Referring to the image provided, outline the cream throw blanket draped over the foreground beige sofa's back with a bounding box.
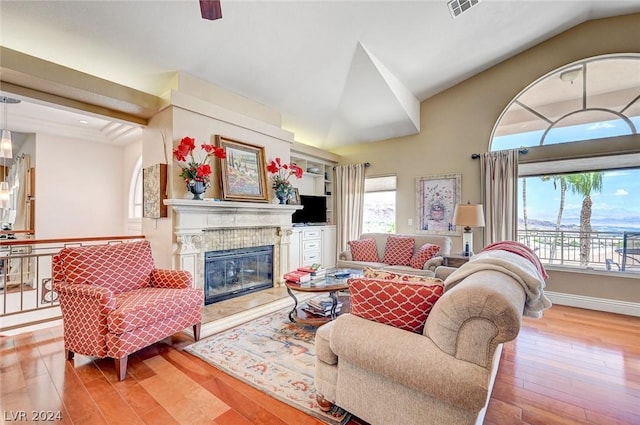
[444,251,551,318]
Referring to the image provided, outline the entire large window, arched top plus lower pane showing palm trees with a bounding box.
[490,54,640,272]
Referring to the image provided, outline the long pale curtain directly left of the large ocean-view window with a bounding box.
[480,149,518,245]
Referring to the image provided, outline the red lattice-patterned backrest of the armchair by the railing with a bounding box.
[59,238,154,295]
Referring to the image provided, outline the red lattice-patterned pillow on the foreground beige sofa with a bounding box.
[348,278,444,333]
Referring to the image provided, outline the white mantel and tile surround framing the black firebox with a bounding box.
[165,199,301,302]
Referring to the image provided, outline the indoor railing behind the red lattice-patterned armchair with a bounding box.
[0,235,144,333]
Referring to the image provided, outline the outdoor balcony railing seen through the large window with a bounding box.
[518,230,640,272]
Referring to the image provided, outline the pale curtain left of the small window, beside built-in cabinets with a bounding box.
[335,164,366,252]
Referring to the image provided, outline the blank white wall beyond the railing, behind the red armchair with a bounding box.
[34,133,130,239]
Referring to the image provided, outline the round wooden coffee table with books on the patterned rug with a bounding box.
[285,270,362,326]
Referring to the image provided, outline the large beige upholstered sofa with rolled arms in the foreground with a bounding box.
[315,265,532,425]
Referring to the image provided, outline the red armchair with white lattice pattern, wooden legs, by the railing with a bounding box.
[53,241,204,381]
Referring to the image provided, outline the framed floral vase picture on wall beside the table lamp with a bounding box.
[416,174,461,235]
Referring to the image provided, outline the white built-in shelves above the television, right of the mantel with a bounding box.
[291,153,334,224]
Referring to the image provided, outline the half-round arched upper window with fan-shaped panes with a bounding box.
[490,54,640,151]
